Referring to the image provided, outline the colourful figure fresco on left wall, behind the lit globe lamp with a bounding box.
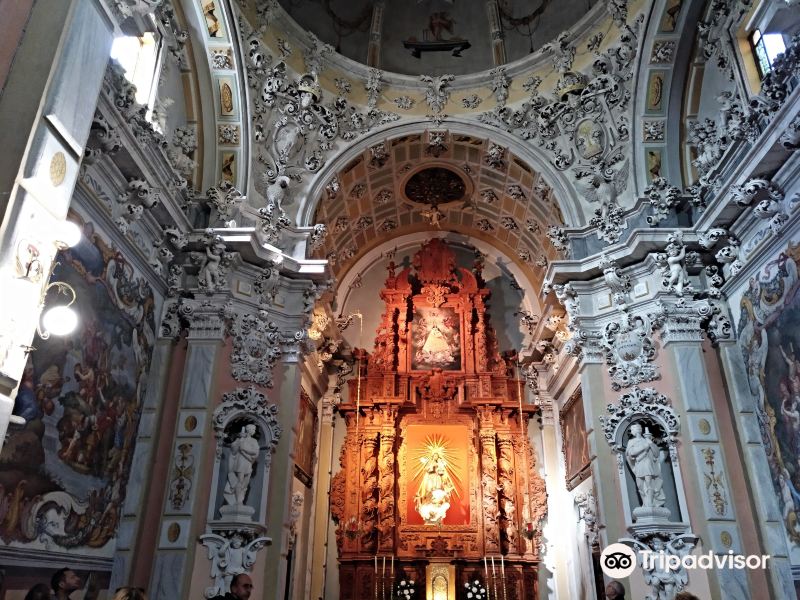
[0,218,156,552]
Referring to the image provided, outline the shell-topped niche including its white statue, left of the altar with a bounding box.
[208,387,281,523]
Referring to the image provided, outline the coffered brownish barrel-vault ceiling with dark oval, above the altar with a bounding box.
[314,131,563,280]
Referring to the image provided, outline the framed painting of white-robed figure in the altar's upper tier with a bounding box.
[411,307,461,371]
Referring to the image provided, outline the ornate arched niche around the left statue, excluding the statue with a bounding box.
[208,386,282,523]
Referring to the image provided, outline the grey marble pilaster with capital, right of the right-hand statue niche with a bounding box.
[661,301,766,600]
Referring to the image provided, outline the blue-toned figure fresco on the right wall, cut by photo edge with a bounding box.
[738,243,800,546]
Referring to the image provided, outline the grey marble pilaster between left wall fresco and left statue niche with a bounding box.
[149,301,225,600]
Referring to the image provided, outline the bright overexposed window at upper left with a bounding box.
[111,31,161,120]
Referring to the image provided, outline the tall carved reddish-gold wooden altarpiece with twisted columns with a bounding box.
[331,239,546,600]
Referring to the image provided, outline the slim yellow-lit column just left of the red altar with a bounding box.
[309,394,341,598]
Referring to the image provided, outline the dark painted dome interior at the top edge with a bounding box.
[280,0,598,75]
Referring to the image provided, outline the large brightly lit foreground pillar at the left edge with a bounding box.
[0,0,114,447]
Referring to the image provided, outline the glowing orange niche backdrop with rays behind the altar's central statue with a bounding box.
[405,425,472,525]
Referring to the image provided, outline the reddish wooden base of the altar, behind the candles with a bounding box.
[339,557,539,600]
